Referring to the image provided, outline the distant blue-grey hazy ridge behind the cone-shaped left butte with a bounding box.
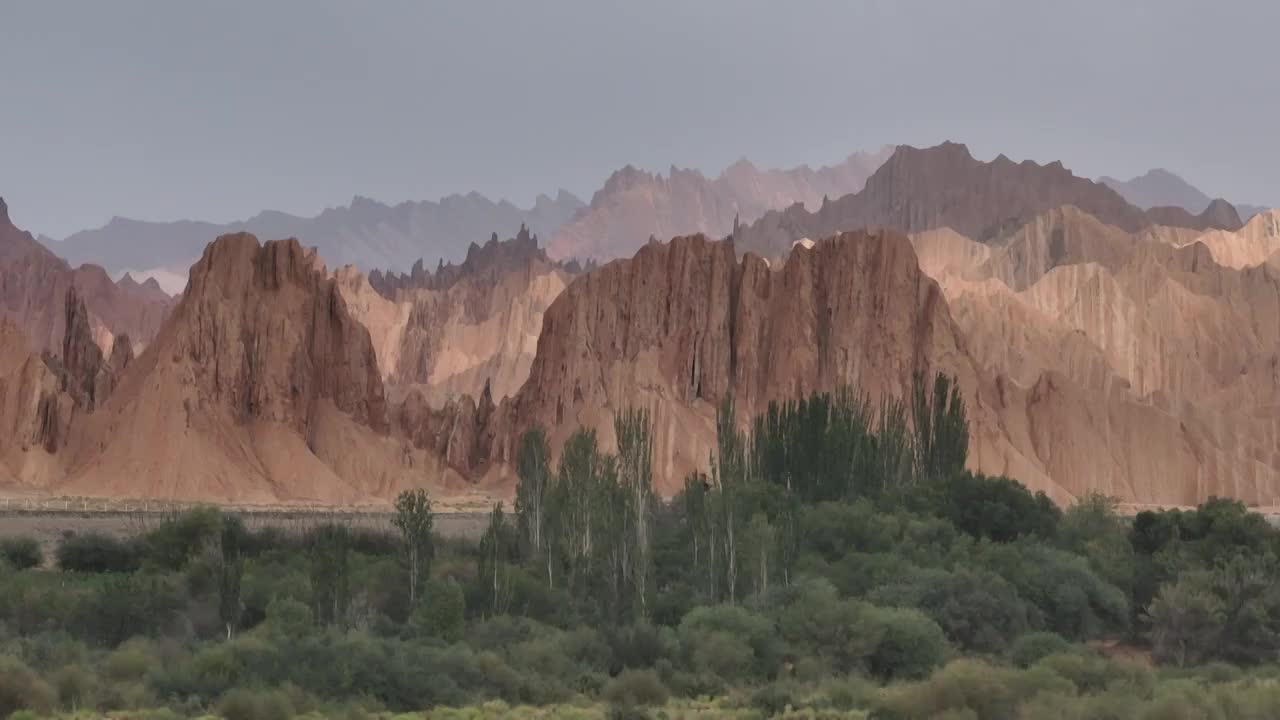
[47,190,584,286]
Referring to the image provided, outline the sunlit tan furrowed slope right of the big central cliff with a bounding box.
[914,209,1280,505]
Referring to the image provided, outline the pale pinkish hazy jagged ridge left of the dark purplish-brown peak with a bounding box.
[548,146,893,260]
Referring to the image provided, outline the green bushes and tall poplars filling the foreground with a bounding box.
[0,377,1280,720]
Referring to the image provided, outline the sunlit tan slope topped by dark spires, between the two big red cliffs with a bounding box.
[337,227,577,407]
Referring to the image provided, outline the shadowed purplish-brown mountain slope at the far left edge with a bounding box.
[0,199,173,352]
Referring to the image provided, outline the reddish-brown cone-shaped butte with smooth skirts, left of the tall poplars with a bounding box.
[55,234,450,503]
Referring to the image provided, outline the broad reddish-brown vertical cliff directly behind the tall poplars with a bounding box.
[476,233,975,493]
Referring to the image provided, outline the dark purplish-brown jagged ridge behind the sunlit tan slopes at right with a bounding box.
[735,142,1239,256]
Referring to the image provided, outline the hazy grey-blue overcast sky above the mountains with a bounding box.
[0,0,1280,237]
